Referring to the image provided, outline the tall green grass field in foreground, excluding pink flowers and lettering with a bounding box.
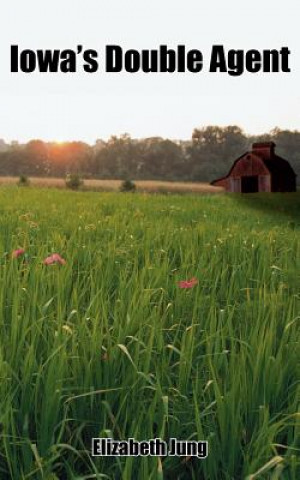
[0,186,300,480]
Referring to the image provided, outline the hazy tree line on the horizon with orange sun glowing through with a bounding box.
[0,126,300,183]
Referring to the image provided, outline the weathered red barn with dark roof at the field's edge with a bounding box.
[211,142,296,193]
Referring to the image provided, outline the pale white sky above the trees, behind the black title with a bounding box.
[0,0,300,143]
